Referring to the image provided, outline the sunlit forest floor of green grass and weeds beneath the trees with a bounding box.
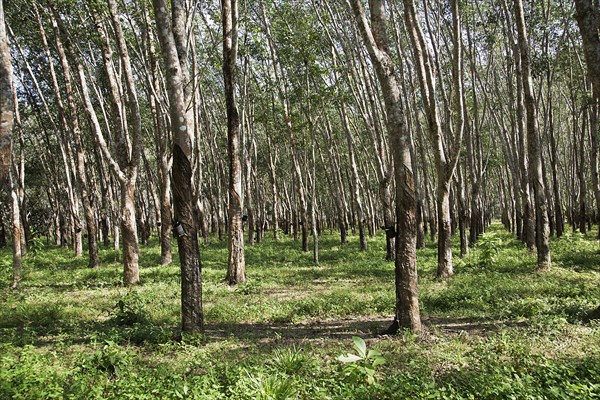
[0,226,600,399]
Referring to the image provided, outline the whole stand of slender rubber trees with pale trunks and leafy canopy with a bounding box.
[0,0,600,331]
